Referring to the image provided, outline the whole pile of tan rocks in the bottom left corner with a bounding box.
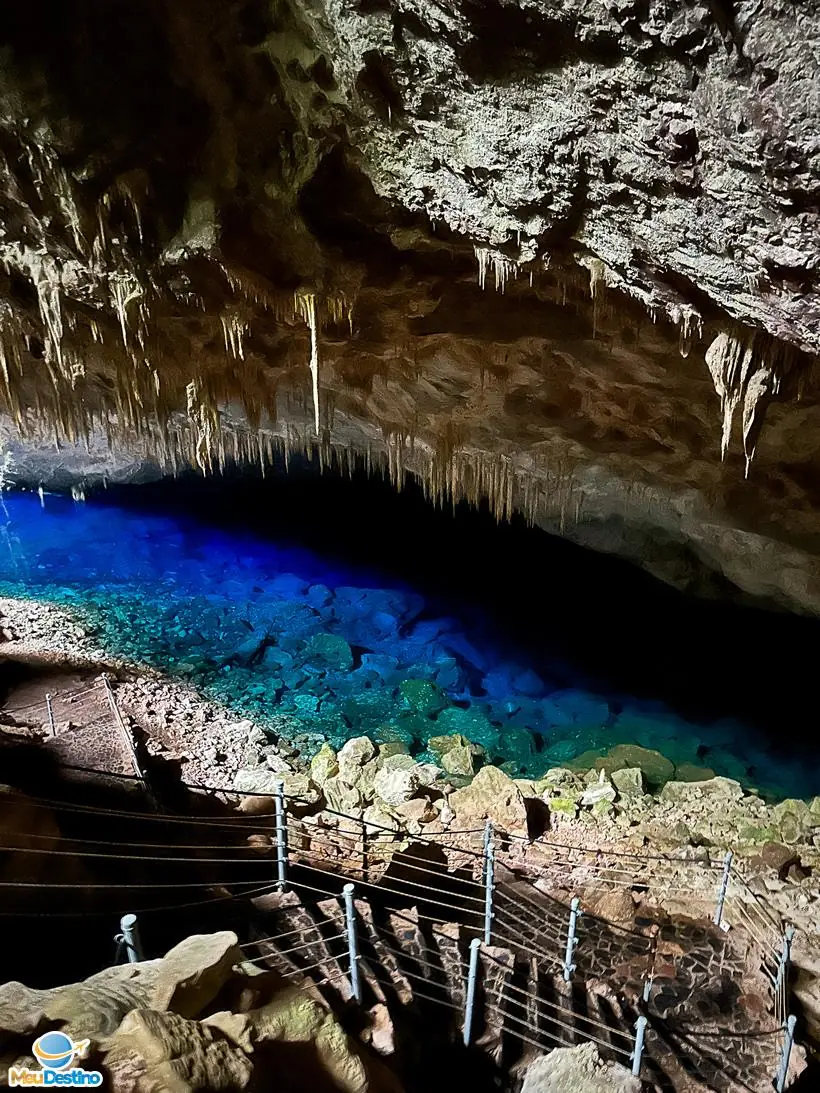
[0,932,399,1093]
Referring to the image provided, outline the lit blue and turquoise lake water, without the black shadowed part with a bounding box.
[0,483,820,796]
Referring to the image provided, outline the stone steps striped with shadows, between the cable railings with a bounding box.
[246,878,773,1093]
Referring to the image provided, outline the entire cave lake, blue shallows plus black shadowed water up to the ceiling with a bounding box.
[0,468,820,797]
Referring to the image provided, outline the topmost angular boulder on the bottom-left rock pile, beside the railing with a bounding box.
[150,930,243,1018]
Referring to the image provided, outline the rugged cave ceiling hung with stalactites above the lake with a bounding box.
[0,0,820,612]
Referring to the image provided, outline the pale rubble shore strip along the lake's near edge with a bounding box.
[0,600,820,1053]
